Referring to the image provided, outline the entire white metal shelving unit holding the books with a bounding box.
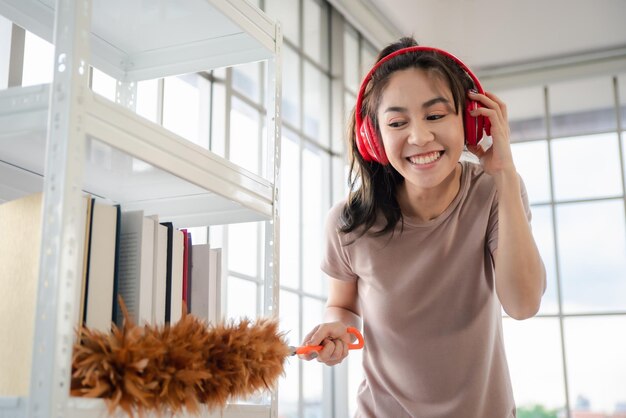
[0,0,282,418]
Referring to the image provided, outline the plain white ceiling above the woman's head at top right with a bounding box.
[361,0,626,72]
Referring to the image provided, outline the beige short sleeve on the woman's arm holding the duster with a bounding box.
[320,202,358,281]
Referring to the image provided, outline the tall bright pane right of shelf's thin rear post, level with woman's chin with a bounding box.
[280,129,300,289]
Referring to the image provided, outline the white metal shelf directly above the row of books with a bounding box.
[0,85,273,227]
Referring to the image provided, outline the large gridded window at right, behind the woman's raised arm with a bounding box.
[496,75,626,417]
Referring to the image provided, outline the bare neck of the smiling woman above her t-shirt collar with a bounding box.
[397,164,463,221]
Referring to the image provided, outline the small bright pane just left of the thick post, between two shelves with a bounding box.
[22,31,54,86]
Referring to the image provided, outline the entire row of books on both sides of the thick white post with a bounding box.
[0,193,222,396]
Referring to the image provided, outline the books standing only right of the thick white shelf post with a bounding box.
[77,193,221,331]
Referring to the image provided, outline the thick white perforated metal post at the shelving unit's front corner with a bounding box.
[27,0,91,418]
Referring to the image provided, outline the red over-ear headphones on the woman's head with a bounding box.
[355,46,491,165]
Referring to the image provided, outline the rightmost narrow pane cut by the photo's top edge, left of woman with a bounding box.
[303,0,329,68]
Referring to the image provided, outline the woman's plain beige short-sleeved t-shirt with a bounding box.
[322,162,530,418]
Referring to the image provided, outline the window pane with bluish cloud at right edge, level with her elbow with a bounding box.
[556,199,626,313]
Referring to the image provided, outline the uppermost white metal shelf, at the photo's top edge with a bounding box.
[0,0,276,81]
